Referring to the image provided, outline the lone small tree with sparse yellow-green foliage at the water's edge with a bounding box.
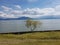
[25,19,41,31]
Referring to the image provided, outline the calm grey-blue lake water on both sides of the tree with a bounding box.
[0,19,60,33]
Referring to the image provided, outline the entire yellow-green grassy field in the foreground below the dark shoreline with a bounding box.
[0,31,60,45]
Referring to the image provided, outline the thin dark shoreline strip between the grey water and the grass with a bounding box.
[0,30,60,34]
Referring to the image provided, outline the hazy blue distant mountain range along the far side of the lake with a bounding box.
[0,15,60,20]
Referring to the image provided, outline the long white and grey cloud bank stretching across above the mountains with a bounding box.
[0,5,60,18]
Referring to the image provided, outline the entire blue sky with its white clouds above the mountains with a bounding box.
[0,0,60,18]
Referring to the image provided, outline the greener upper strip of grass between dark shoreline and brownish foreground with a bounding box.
[0,32,60,39]
